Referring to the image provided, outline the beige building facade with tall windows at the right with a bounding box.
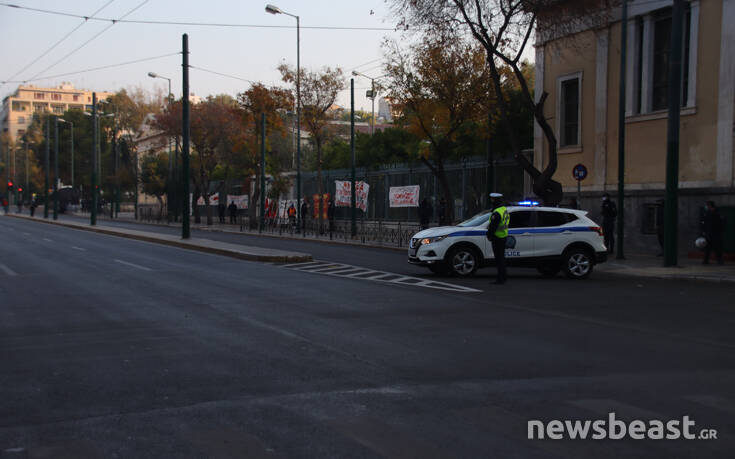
[534,0,735,251]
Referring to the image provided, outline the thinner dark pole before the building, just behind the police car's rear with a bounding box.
[617,0,628,260]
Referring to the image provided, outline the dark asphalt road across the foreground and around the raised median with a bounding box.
[0,217,735,459]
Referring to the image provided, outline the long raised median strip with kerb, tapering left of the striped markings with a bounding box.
[8,215,313,263]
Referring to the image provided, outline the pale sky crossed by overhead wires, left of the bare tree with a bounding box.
[0,0,399,111]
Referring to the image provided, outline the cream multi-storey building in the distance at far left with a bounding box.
[0,83,113,141]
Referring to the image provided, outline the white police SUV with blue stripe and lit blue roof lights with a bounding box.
[408,206,607,279]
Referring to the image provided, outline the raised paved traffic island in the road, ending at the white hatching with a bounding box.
[8,213,312,263]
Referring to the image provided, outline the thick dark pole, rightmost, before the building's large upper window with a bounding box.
[664,0,684,266]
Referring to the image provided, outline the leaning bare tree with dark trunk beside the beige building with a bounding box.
[392,0,614,206]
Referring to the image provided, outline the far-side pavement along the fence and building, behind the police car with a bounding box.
[59,214,735,283]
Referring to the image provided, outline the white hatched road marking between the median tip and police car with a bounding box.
[282,260,482,293]
